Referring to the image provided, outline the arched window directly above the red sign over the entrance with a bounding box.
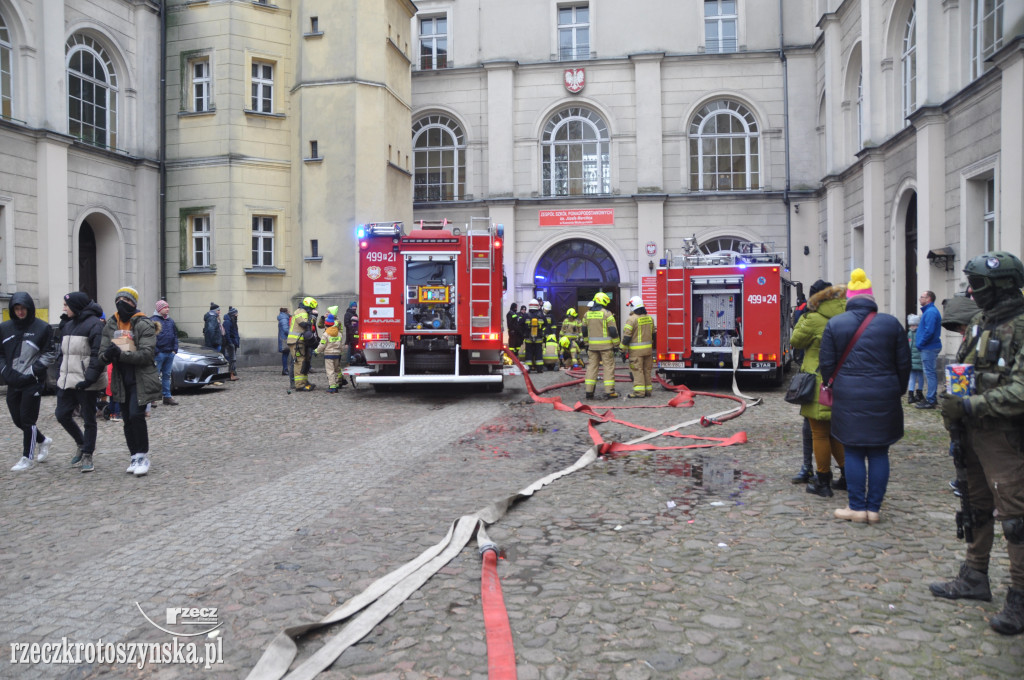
[541,107,611,196]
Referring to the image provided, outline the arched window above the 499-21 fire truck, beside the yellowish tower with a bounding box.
[413,115,466,201]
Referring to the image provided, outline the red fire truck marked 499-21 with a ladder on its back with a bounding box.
[354,217,505,391]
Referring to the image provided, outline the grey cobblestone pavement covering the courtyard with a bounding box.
[0,368,1024,680]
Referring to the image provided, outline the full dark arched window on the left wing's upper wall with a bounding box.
[66,35,118,148]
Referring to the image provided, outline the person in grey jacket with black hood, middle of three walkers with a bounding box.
[53,291,106,472]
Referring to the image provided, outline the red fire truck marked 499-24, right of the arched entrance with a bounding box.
[656,238,793,384]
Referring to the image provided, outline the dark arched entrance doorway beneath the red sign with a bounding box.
[534,239,620,321]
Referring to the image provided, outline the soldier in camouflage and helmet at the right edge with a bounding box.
[931,252,1024,635]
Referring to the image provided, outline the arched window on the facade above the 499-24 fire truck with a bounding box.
[690,99,761,192]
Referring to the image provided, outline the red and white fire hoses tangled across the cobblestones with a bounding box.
[247,348,761,680]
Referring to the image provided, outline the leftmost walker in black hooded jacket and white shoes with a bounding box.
[0,291,57,472]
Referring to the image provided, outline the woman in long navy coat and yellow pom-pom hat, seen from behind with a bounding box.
[818,269,910,524]
